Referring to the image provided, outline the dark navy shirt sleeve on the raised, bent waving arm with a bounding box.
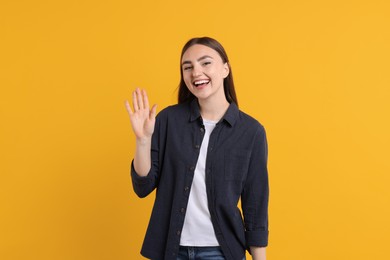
[130,112,161,198]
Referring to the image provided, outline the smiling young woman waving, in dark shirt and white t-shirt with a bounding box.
[126,37,268,260]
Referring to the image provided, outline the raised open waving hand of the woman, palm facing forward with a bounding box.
[125,88,157,142]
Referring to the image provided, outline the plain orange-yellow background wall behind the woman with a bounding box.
[0,0,390,260]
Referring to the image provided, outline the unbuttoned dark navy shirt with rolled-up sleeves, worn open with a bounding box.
[131,99,269,260]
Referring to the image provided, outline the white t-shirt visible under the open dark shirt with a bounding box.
[180,120,219,246]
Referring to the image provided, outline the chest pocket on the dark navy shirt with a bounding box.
[225,149,250,181]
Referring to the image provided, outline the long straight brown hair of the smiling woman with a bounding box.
[178,37,238,106]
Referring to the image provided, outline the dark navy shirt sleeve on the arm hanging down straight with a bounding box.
[241,126,269,249]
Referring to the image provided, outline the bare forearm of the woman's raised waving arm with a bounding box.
[134,138,152,176]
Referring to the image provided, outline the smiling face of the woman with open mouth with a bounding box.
[181,44,229,100]
